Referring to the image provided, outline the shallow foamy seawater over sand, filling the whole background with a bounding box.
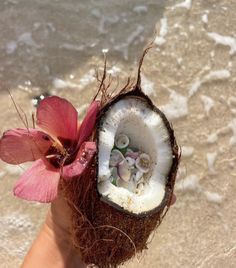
[0,0,236,268]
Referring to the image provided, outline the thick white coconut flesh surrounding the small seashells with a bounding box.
[98,96,173,214]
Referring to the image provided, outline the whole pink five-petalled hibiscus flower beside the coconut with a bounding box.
[0,96,100,202]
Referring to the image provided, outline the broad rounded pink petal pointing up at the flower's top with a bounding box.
[37,96,78,141]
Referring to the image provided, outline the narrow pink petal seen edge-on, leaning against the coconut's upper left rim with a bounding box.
[78,101,100,147]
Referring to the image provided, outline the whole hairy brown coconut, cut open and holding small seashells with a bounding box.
[64,48,179,268]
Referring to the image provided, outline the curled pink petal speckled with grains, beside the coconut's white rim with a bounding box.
[62,142,96,180]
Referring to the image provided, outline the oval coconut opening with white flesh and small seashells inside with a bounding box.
[97,94,175,215]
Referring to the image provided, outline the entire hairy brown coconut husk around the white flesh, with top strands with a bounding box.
[63,48,179,268]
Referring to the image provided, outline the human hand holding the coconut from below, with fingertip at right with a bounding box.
[22,191,176,268]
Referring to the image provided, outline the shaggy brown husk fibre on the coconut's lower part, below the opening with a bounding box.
[65,152,178,268]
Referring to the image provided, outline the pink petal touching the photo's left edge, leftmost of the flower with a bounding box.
[0,128,52,165]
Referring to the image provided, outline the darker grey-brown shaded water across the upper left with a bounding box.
[0,0,165,88]
